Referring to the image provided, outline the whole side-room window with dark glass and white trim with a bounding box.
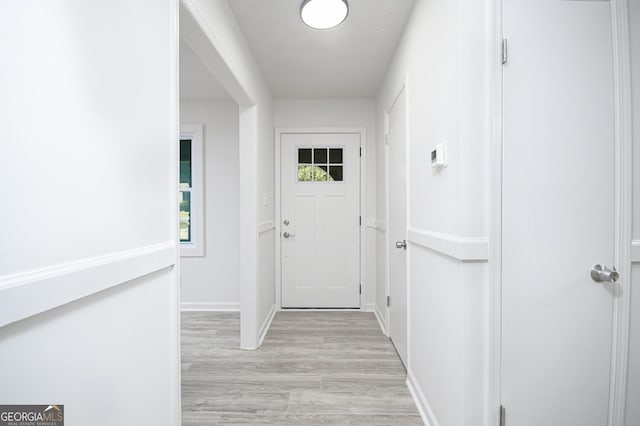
[178,125,204,257]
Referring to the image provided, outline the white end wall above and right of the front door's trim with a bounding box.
[274,99,376,309]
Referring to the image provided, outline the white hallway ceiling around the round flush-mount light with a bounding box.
[228,0,415,98]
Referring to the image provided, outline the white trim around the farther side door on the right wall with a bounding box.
[383,73,411,371]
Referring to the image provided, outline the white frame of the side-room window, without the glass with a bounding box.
[178,124,205,257]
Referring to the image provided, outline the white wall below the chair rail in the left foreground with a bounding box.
[0,270,175,426]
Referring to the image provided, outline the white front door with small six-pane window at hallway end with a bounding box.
[280,133,360,308]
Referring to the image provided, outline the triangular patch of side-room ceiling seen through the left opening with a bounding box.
[180,40,231,100]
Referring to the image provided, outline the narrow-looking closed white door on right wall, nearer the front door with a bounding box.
[387,90,407,365]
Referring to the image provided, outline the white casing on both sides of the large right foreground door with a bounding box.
[485,0,633,426]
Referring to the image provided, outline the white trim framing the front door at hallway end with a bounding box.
[275,127,370,311]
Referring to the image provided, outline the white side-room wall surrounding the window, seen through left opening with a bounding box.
[180,99,240,310]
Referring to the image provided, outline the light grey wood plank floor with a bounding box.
[182,312,423,426]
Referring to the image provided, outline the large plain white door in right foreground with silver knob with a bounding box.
[502,0,615,426]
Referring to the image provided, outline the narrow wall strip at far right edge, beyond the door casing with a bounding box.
[626,0,640,426]
